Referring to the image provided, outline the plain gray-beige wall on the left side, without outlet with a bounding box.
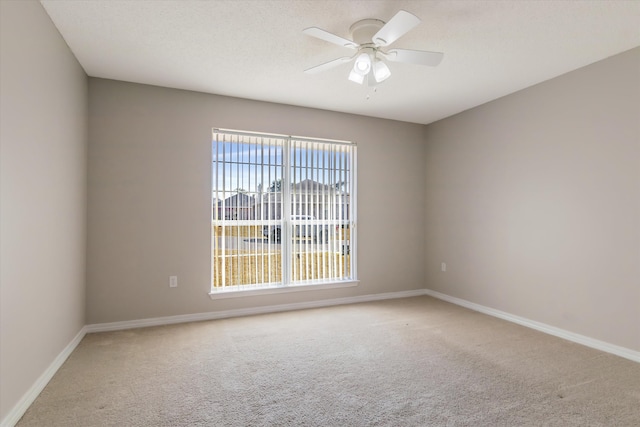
[0,1,87,419]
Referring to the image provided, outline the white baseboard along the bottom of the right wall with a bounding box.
[423,289,640,363]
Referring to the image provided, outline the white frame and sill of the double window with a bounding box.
[209,128,359,299]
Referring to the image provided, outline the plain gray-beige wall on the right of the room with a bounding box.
[424,48,640,351]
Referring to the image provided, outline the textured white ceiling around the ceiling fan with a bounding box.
[41,0,640,124]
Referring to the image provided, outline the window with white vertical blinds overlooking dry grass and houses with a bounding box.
[211,129,356,296]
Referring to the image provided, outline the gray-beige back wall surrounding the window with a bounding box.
[87,78,425,323]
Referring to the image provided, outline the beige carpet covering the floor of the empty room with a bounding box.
[18,297,640,427]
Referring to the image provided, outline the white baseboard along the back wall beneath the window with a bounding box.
[86,289,424,333]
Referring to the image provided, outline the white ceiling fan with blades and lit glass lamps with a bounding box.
[302,10,444,86]
